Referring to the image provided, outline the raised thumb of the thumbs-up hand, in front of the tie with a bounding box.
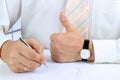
[60,12,76,32]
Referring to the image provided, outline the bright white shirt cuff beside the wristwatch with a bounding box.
[93,39,120,64]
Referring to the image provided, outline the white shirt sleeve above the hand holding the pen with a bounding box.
[0,0,21,48]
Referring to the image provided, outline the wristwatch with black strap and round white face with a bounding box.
[80,39,90,62]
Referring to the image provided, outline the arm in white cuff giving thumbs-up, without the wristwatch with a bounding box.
[51,14,120,63]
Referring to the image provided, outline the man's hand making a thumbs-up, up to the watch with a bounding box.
[50,13,84,62]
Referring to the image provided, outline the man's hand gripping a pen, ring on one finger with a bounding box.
[1,39,45,72]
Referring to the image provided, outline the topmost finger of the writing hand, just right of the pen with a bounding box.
[26,39,44,54]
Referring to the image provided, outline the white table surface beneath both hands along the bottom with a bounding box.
[0,51,120,80]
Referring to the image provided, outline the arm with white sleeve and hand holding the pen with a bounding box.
[0,0,45,72]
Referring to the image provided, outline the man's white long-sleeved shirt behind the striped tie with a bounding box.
[0,0,120,62]
